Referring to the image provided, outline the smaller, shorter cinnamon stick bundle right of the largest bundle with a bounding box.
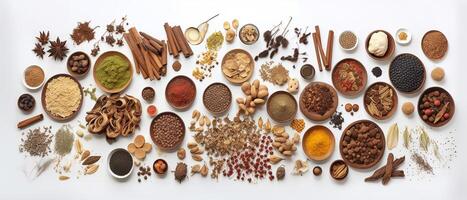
[164,23,193,58]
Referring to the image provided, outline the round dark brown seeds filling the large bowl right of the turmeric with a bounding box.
[342,122,384,165]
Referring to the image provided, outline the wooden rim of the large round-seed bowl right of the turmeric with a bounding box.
[339,119,386,169]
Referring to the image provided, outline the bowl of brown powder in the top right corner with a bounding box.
[422,31,448,60]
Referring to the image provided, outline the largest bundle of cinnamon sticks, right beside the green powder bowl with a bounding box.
[123,27,167,80]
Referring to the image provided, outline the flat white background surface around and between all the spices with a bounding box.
[0,0,467,199]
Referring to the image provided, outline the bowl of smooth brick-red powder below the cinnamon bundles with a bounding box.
[165,75,196,109]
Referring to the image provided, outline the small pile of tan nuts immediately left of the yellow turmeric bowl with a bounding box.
[272,125,300,157]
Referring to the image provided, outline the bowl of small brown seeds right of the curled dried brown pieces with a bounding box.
[151,113,185,149]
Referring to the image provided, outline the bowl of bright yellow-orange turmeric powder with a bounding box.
[303,126,334,160]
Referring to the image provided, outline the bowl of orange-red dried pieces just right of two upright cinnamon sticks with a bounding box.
[332,58,368,97]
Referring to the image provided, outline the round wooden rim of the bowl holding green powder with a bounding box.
[93,51,133,94]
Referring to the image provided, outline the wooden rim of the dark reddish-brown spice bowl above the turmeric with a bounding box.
[299,82,339,121]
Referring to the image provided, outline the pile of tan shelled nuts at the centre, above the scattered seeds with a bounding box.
[237,80,269,115]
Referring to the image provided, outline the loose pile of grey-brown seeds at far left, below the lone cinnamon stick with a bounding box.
[19,127,53,157]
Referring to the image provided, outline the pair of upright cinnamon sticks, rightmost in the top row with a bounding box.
[313,26,334,71]
